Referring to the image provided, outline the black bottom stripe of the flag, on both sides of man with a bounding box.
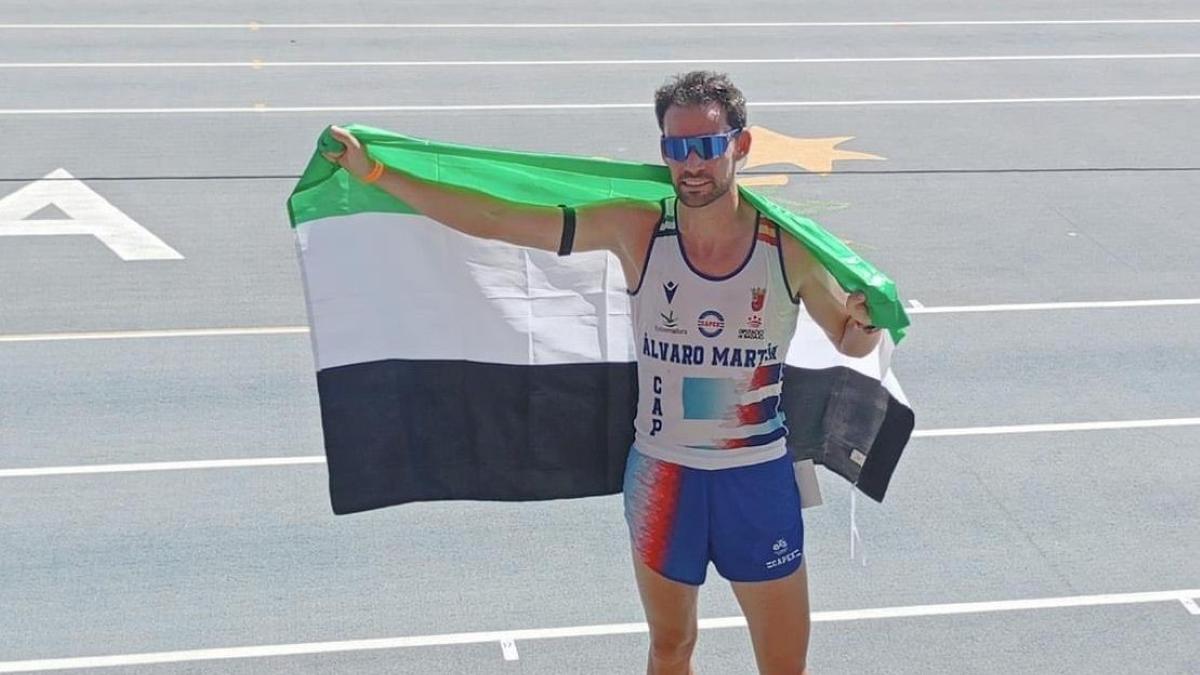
[317,359,913,515]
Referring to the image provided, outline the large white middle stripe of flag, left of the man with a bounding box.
[296,214,634,370]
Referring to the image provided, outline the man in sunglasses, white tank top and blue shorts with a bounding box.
[326,71,880,675]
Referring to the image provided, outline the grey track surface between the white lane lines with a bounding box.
[0,0,1200,675]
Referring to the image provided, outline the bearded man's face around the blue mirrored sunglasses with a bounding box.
[662,103,750,207]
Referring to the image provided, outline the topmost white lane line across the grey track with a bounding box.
[0,18,1200,30]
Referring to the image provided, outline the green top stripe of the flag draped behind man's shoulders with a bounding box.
[288,125,910,344]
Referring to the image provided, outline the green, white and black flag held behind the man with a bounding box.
[288,126,913,514]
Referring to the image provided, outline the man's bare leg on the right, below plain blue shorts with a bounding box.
[732,565,810,675]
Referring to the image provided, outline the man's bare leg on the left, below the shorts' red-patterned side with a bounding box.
[634,554,700,675]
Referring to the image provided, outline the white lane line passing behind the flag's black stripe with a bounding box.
[0,417,1200,478]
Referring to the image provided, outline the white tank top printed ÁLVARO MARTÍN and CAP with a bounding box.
[630,198,799,468]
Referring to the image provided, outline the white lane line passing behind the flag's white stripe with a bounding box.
[0,298,1200,344]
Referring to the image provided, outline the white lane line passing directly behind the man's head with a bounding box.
[0,94,1200,115]
